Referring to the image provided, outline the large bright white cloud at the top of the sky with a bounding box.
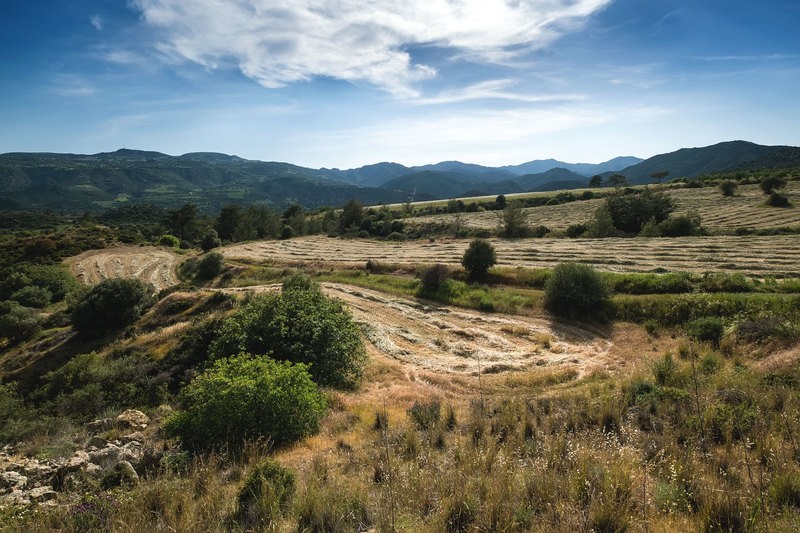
[132,0,612,96]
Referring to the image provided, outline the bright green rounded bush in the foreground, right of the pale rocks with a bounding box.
[165,354,326,450]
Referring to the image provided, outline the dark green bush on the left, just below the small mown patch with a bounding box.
[72,279,154,334]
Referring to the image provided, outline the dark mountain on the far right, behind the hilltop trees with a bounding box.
[620,141,796,184]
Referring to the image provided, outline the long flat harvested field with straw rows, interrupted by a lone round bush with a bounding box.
[220,235,800,277]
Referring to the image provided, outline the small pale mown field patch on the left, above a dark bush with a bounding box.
[66,246,179,290]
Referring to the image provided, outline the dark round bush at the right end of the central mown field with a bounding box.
[544,263,611,318]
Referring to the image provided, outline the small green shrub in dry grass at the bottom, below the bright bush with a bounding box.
[236,459,295,528]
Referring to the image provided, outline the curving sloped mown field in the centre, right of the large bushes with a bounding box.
[323,283,611,375]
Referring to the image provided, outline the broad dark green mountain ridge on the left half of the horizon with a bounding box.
[0,150,406,211]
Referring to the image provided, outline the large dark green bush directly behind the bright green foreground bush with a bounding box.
[209,286,366,387]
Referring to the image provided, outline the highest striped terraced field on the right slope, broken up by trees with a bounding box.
[408,181,800,230]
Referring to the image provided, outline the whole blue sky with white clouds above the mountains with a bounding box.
[0,0,800,168]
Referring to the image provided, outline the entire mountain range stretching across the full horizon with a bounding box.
[0,141,800,212]
